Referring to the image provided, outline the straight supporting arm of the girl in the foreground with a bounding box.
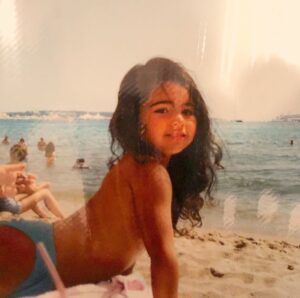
[133,163,178,298]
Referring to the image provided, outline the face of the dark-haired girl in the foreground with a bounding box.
[140,82,197,162]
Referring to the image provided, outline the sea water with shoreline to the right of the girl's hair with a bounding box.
[207,121,300,239]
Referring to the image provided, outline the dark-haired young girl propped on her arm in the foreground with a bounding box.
[0,58,219,298]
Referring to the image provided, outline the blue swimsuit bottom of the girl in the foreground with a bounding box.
[0,219,56,298]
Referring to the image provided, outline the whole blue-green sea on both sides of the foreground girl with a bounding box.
[0,116,300,239]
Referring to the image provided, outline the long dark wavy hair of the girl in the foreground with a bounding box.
[108,58,222,229]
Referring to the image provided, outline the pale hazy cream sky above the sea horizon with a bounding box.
[0,0,300,121]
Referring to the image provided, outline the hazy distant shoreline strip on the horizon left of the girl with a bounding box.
[0,111,112,122]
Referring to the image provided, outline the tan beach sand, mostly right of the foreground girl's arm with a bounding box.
[0,212,300,298]
